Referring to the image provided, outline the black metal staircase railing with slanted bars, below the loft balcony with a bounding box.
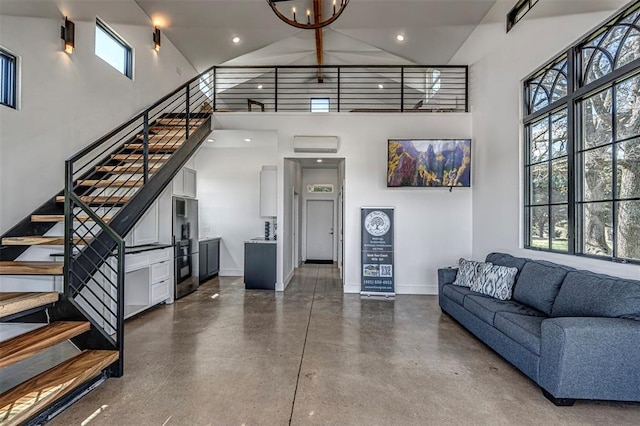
[64,70,213,375]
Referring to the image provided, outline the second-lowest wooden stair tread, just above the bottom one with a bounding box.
[0,321,91,368]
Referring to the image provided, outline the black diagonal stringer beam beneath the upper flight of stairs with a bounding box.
[69,116,211,290]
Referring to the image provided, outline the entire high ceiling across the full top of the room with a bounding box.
[0,0,623,71]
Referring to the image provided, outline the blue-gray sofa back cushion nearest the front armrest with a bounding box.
[551,271,640,321]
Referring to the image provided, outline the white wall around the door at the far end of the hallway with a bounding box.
[301,168,339,261]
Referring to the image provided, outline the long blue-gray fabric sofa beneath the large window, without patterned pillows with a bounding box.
[438,253,640,405]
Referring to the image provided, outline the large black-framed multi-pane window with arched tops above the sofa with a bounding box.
[524,3,640,262]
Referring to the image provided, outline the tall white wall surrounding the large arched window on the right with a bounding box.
[452,0,640,278]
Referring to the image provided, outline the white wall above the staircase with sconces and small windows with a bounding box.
[0,10,196,233]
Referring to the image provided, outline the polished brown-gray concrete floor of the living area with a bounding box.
[50,265,640,426]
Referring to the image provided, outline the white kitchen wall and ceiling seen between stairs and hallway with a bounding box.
[195,130,280,276]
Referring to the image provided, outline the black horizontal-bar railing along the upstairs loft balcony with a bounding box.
[206,65,469,113]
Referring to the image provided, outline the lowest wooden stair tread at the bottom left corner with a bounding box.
[0,350,118,425]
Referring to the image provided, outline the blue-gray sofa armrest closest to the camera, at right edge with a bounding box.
[539,317,640,401]
